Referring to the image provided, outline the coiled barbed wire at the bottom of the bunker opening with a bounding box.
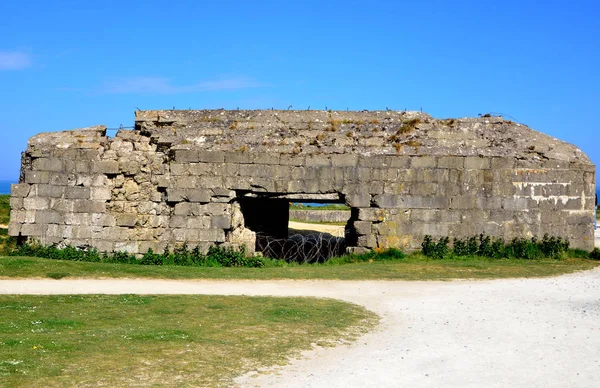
[256,233,346,264]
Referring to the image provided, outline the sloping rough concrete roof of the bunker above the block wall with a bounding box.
[135,109,591,164]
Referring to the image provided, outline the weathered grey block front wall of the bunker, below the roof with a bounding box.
[9,112,595,253]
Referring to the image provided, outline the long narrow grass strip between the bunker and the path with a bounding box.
[0,254,600,280]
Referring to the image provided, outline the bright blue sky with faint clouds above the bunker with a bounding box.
[0,0,600,188]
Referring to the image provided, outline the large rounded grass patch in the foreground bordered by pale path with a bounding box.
[0,295,377,387]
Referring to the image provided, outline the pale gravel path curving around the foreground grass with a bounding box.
[0,268,600,388]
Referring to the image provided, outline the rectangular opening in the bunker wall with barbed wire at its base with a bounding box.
[240,198,358,263]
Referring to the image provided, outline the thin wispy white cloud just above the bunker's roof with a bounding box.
[103,77,266,94]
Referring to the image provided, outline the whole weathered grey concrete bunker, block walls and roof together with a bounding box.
[9,110,595,254]
